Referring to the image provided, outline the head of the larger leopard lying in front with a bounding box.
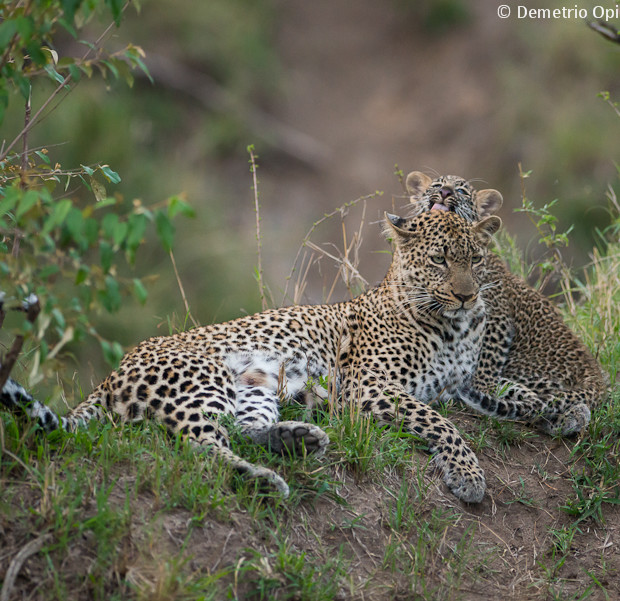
[385,211,502,318]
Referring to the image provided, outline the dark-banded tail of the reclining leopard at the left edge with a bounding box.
[0,378,103,432]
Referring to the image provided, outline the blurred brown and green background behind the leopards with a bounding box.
[1,0,620,379]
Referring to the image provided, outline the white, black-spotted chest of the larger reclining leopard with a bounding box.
[409,310,484,403]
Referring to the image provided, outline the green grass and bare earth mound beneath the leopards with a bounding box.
[0,207,620,601]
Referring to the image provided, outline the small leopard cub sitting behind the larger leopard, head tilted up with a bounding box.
[407,171,606,435]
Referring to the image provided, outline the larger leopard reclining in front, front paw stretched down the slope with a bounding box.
[0,211,501,502]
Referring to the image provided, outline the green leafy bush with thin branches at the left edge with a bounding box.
[0,0,193,385]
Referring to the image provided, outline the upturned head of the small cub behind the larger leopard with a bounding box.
[406,171,503,223]
